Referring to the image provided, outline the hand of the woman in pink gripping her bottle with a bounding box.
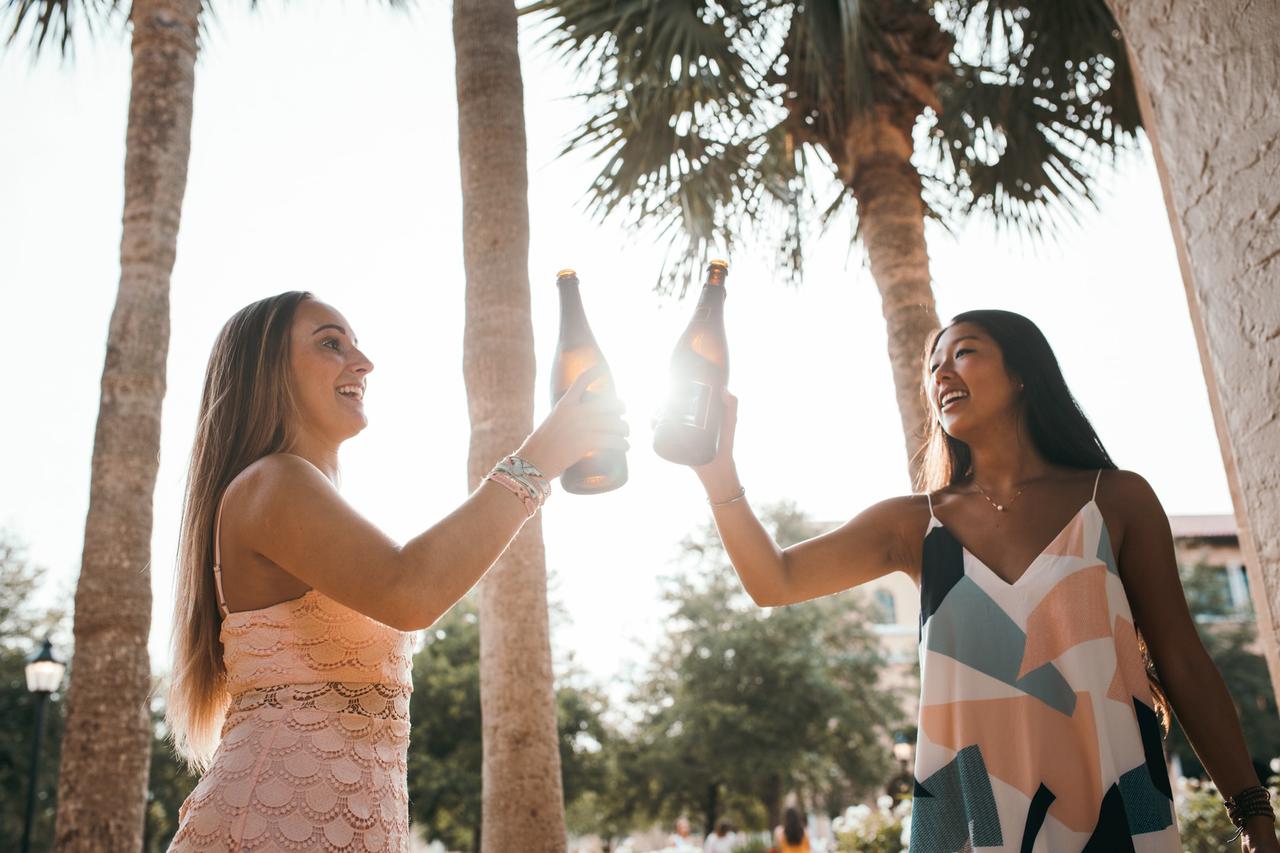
[516,365,630,480]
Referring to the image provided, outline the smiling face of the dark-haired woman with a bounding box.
[928,323,1021,443]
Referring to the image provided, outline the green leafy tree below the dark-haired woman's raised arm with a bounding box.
[618,505,900,827]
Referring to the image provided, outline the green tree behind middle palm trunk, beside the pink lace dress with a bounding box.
[408,598,611,850]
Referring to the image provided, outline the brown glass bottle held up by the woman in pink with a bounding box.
[552,269,627,494]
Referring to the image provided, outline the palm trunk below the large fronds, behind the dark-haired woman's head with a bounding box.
[842,106,938,483]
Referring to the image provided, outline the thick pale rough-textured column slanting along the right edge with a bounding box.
[1108,0,1280,694]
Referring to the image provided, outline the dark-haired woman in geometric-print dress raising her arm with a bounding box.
[680,311,1280,853]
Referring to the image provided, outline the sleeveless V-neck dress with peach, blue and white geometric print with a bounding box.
[910,471,1181,853]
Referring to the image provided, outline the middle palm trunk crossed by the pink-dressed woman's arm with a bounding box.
[453,0,566,853]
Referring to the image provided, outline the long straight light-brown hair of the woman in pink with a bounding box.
[165,291,314,770]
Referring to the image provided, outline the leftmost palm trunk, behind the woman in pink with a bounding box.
[54,0,200,850]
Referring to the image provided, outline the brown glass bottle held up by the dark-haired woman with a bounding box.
[653,260,728,465]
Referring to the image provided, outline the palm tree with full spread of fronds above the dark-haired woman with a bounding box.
[524,0,1139,478]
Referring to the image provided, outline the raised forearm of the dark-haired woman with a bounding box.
[699,470,787,607]
